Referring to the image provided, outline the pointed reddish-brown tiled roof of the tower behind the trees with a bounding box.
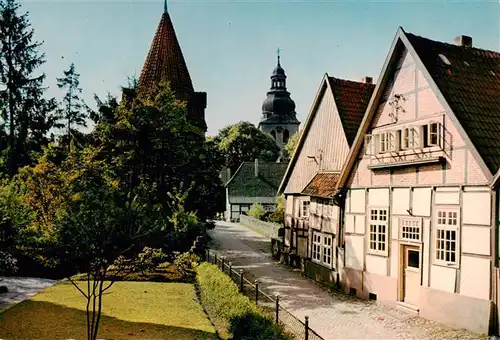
[139,2,194,100]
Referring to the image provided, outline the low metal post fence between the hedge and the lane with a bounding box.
[205,249,324,340]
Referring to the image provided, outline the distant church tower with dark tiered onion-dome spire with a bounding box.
[259,49,300,149]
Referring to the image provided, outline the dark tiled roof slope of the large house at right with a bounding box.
[406,33,500,173]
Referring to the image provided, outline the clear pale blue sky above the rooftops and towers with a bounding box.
[22,0,500,135]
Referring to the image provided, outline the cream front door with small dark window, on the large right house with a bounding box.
[403,245,421,306]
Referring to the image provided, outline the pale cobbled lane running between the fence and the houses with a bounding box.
[210,222,486,340]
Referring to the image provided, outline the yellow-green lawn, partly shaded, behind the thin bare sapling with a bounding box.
[0,281,217,340]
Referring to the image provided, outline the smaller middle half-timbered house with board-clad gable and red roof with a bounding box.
[279,74,375,264]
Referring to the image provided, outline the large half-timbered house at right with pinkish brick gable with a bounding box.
[336,28,500,333]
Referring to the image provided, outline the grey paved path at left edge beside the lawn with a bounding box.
[0,277,57,313]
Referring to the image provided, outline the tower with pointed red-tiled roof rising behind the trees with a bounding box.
[130,0,207,132]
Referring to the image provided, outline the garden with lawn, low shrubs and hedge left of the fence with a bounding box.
[0,248,290,340]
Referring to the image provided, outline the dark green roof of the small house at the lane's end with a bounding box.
[226,162,287,197]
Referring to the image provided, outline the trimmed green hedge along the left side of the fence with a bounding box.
[196,262,291,340]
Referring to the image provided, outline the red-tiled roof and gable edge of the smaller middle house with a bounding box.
[279,73,375,193]
